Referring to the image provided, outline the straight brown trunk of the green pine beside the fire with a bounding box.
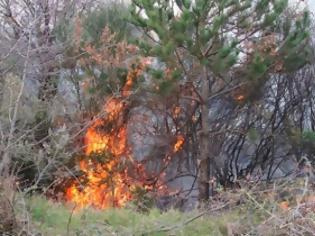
[198,69,210,203]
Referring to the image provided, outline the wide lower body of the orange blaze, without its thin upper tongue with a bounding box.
[66,100,132,208]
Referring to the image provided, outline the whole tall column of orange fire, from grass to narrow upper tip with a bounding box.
[65,63,147,209]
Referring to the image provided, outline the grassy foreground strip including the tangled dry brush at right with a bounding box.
[16,181,315,236]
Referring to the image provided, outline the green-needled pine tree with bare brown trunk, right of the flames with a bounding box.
[130,0,309,202]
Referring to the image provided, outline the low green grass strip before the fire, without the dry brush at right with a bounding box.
[23,197,238,236]
